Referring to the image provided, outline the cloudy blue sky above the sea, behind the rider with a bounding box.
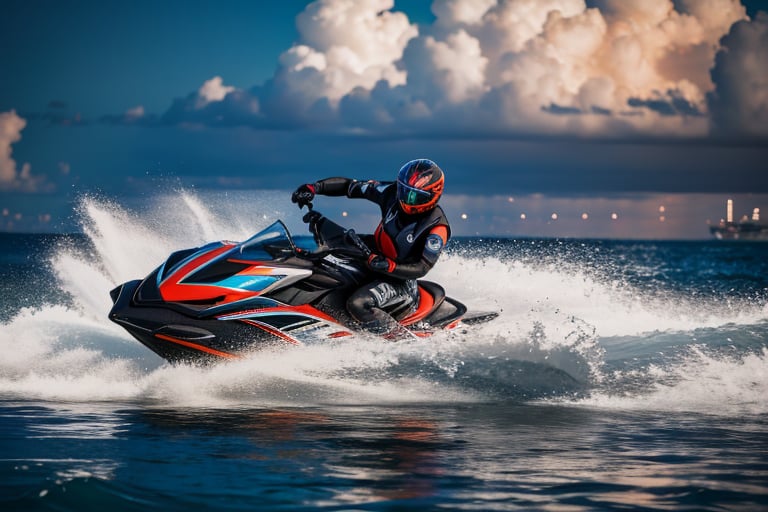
[0,0,768,239]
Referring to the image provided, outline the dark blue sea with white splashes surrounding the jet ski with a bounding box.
[0,193,768,511]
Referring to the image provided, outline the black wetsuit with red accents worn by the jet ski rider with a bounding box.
[313,178,451,332]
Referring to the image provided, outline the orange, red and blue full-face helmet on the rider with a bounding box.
[397,158,445,215]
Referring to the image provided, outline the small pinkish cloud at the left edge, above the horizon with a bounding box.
[0,110,50,192]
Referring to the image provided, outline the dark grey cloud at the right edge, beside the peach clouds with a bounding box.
[708,12,768,137]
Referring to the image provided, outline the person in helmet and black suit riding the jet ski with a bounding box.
[291,159,451,337]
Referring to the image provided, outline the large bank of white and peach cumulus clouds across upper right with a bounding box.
[163,0,768,137]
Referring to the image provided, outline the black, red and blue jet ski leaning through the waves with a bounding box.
[109,209,497,363]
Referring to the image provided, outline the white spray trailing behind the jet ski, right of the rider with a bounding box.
[429,255,768,341]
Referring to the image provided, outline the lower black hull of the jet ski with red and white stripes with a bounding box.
[109,280,492,364]
